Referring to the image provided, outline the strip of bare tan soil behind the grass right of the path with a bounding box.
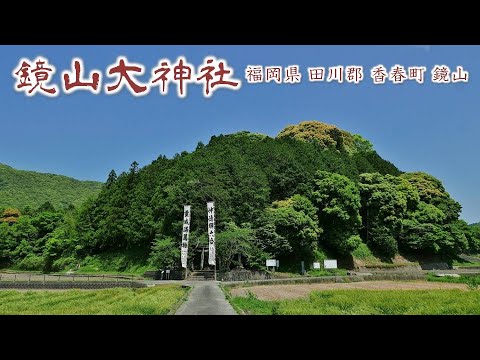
[231,281,468,300]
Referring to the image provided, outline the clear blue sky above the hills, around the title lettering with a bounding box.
[0,45,480,222]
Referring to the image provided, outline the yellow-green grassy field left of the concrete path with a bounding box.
[0,285,187,315]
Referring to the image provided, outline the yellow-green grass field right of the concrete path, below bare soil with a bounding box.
[230,290,480,315]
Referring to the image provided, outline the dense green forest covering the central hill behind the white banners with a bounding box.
[0,121,480,271]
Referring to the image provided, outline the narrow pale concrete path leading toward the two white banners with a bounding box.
[175,281,237,315]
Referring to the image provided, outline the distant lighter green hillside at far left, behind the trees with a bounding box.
[0,164,102,210]
